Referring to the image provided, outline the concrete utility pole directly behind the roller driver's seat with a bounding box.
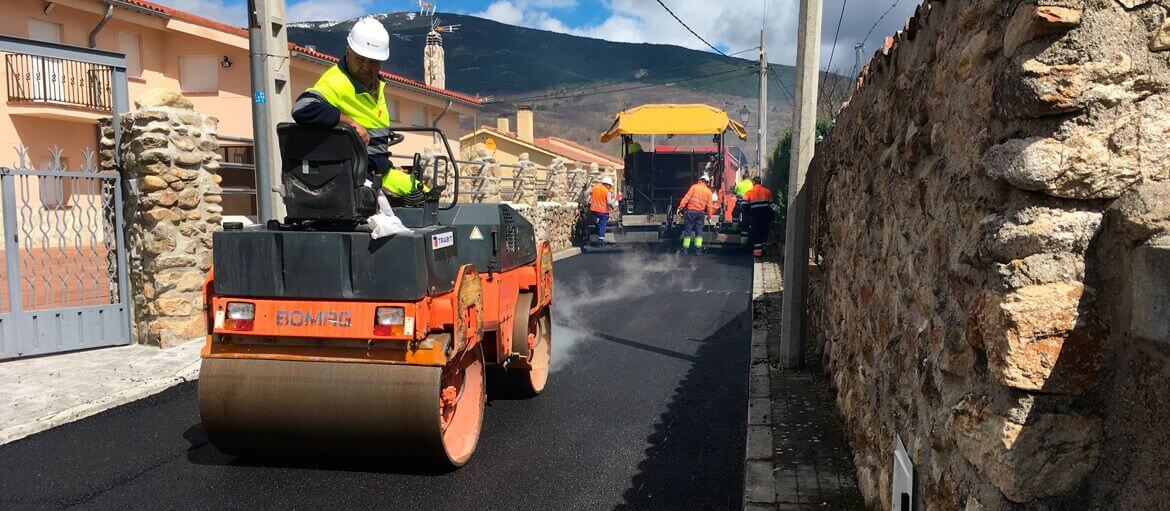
[248,0,293,223]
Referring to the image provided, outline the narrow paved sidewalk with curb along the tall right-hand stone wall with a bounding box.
[744,258,866,511]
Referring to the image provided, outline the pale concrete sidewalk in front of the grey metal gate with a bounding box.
[0,340,204,444]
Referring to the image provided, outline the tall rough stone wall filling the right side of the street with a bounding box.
[810,0,1170,510]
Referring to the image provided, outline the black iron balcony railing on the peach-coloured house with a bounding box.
[5,54,113,111]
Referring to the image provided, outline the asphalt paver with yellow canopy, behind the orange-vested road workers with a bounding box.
[578,104,748,243]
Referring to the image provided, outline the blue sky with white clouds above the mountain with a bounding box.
[154,0,918,68]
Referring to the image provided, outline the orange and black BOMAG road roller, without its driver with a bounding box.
[199,124,552,468]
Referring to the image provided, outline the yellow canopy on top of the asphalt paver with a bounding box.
[601,104,748,143]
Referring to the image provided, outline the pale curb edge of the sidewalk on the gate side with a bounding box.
[0,360,200,446]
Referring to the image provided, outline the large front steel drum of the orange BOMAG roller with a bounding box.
[199,346,487,468]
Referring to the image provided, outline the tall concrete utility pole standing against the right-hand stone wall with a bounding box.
[779,0,824,368]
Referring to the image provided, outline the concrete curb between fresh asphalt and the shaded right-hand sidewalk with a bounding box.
[742,260,776,510]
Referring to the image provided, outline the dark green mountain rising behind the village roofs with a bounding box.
[289,13,809,159]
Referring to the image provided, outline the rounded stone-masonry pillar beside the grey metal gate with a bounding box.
[103,90,223,347]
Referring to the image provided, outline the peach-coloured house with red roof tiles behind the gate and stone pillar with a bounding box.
[0,0,480,216]
